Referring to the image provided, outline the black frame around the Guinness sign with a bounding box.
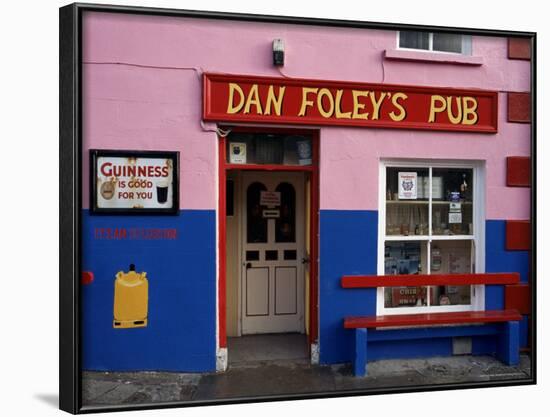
[89,149,179,216]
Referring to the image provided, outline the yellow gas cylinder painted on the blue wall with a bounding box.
[113,264,149,329]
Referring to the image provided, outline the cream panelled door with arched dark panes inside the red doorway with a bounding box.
[240,172,307,334]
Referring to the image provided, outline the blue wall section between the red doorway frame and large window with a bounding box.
[319,210,378,363]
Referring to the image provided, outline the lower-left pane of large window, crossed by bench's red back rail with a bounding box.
[384,242,428,308]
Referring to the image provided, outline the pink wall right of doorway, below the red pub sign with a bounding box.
[321,94,530,219]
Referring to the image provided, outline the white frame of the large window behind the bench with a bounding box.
[376,159,485,315]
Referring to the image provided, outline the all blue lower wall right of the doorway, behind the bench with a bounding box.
[319,210,529,364]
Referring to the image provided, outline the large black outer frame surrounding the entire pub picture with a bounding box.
[59,3,537,414]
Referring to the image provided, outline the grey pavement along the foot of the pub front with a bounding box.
[82,355,531,406]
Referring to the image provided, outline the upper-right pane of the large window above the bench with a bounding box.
[432,168,474,235]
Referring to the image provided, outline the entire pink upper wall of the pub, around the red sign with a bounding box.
[83,13,530,219]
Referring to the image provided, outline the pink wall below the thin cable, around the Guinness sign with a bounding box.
[83,64,217,209]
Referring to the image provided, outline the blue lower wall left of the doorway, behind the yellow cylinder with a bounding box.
[82,210,216,372]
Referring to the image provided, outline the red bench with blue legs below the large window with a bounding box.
[341,273,522,376]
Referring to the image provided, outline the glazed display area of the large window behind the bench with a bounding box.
[383,166,477,310]
